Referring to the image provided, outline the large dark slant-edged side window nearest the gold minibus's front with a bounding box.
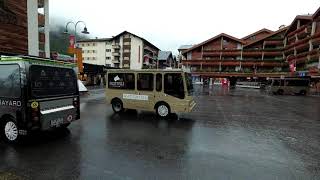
[164,73,185,99]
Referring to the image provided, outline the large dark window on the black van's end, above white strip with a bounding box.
[30,65,78,98]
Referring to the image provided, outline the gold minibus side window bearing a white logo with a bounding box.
[108,73,135,89]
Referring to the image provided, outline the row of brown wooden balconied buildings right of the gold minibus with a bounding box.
[182,8,320,78]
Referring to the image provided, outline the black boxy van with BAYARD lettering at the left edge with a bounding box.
[0,56,80,142]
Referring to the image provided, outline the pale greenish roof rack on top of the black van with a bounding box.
[0,52,76,67]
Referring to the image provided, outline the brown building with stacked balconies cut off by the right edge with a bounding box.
[284,12,320,76]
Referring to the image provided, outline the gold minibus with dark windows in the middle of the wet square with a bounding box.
[106,69,196,117]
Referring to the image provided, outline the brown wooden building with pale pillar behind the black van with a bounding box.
[0,0,50,57]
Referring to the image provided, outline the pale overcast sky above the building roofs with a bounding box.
[49,0,320,53]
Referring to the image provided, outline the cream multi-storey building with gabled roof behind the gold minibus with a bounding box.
[77,31,159,69]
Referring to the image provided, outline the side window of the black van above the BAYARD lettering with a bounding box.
[0,64,21,97]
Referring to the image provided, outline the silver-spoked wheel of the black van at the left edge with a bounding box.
[1,119,19,143]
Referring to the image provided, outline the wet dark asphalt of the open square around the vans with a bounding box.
[0,86,320,180]
